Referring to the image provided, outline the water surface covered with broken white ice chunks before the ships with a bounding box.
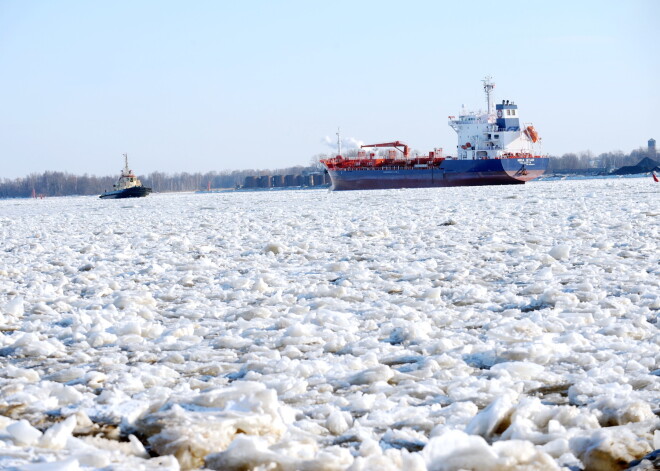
[0,179,660,471]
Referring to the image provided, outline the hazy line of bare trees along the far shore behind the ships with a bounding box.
[0,147,647,198]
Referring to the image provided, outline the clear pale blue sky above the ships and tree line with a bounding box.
[0,0,660,178]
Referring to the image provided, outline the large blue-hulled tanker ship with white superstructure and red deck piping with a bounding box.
[321,77,548,191]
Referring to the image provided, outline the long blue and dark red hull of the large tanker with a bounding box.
[328,157,549,191]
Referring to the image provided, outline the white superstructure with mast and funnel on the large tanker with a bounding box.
[449,77,539,160]
